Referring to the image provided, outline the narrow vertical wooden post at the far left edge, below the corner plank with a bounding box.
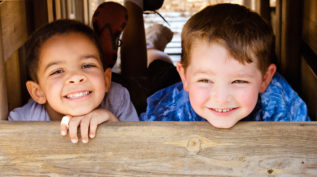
[0,15,8,120]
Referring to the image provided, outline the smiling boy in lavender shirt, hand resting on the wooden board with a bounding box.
[8,20,138,143]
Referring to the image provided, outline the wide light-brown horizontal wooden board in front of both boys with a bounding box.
[0,121,317,177]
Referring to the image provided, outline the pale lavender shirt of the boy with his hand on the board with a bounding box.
[8,82,139,121]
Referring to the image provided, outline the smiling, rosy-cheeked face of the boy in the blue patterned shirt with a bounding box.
[177,41,272,128]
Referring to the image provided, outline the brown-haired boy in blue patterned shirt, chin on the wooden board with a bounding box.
[141,4,310,128]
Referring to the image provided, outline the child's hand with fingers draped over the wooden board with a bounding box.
[60,108,119,143]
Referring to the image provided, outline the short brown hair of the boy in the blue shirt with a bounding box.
[181,3,273,74]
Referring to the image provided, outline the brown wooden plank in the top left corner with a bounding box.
[0,0,28,61]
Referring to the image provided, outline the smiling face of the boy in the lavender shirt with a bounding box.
[32,33,111,116]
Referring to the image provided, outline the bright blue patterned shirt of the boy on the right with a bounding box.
[140,73,310,121]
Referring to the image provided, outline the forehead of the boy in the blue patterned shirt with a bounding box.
[188,40,260,73]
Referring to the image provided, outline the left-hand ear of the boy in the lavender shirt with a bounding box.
[26,81,46,104]
